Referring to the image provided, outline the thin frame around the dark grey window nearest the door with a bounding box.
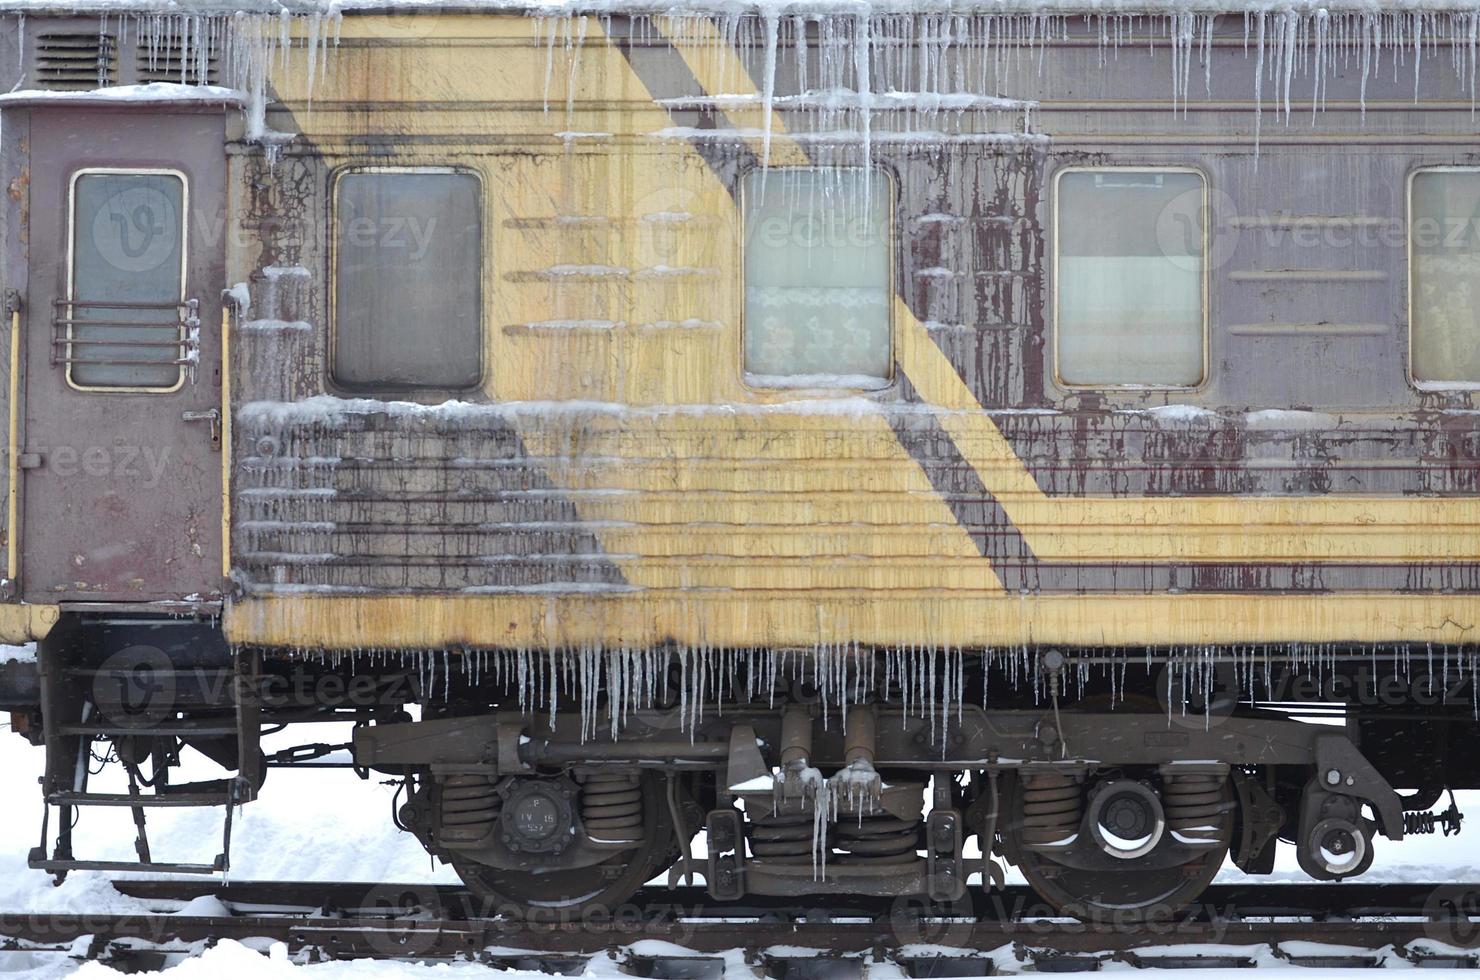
[324,163,488,397]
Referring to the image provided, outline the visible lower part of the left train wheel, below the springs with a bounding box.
[450,773,678,918]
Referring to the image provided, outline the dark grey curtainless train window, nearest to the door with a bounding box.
[333,167,482,389]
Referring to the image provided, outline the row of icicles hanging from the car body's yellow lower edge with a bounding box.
[275,644,1480,751]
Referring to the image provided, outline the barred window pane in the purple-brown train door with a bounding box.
[61,170,186,391]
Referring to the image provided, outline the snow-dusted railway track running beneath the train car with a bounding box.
[0,879,1480,980]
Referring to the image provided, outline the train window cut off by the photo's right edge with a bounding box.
[1407,167,1480,388]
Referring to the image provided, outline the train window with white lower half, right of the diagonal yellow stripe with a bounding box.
[1054,167,1206,388]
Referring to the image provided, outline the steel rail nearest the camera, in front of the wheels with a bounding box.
[0,913,1480,968]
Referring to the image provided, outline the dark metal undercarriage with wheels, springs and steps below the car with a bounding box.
[9,617,1480,922]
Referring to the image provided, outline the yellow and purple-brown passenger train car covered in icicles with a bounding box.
[0,0,1480,922]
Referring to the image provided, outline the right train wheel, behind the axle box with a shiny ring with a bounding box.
[1003,776,1234,925]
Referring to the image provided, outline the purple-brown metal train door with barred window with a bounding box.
[18,105,226,603]
